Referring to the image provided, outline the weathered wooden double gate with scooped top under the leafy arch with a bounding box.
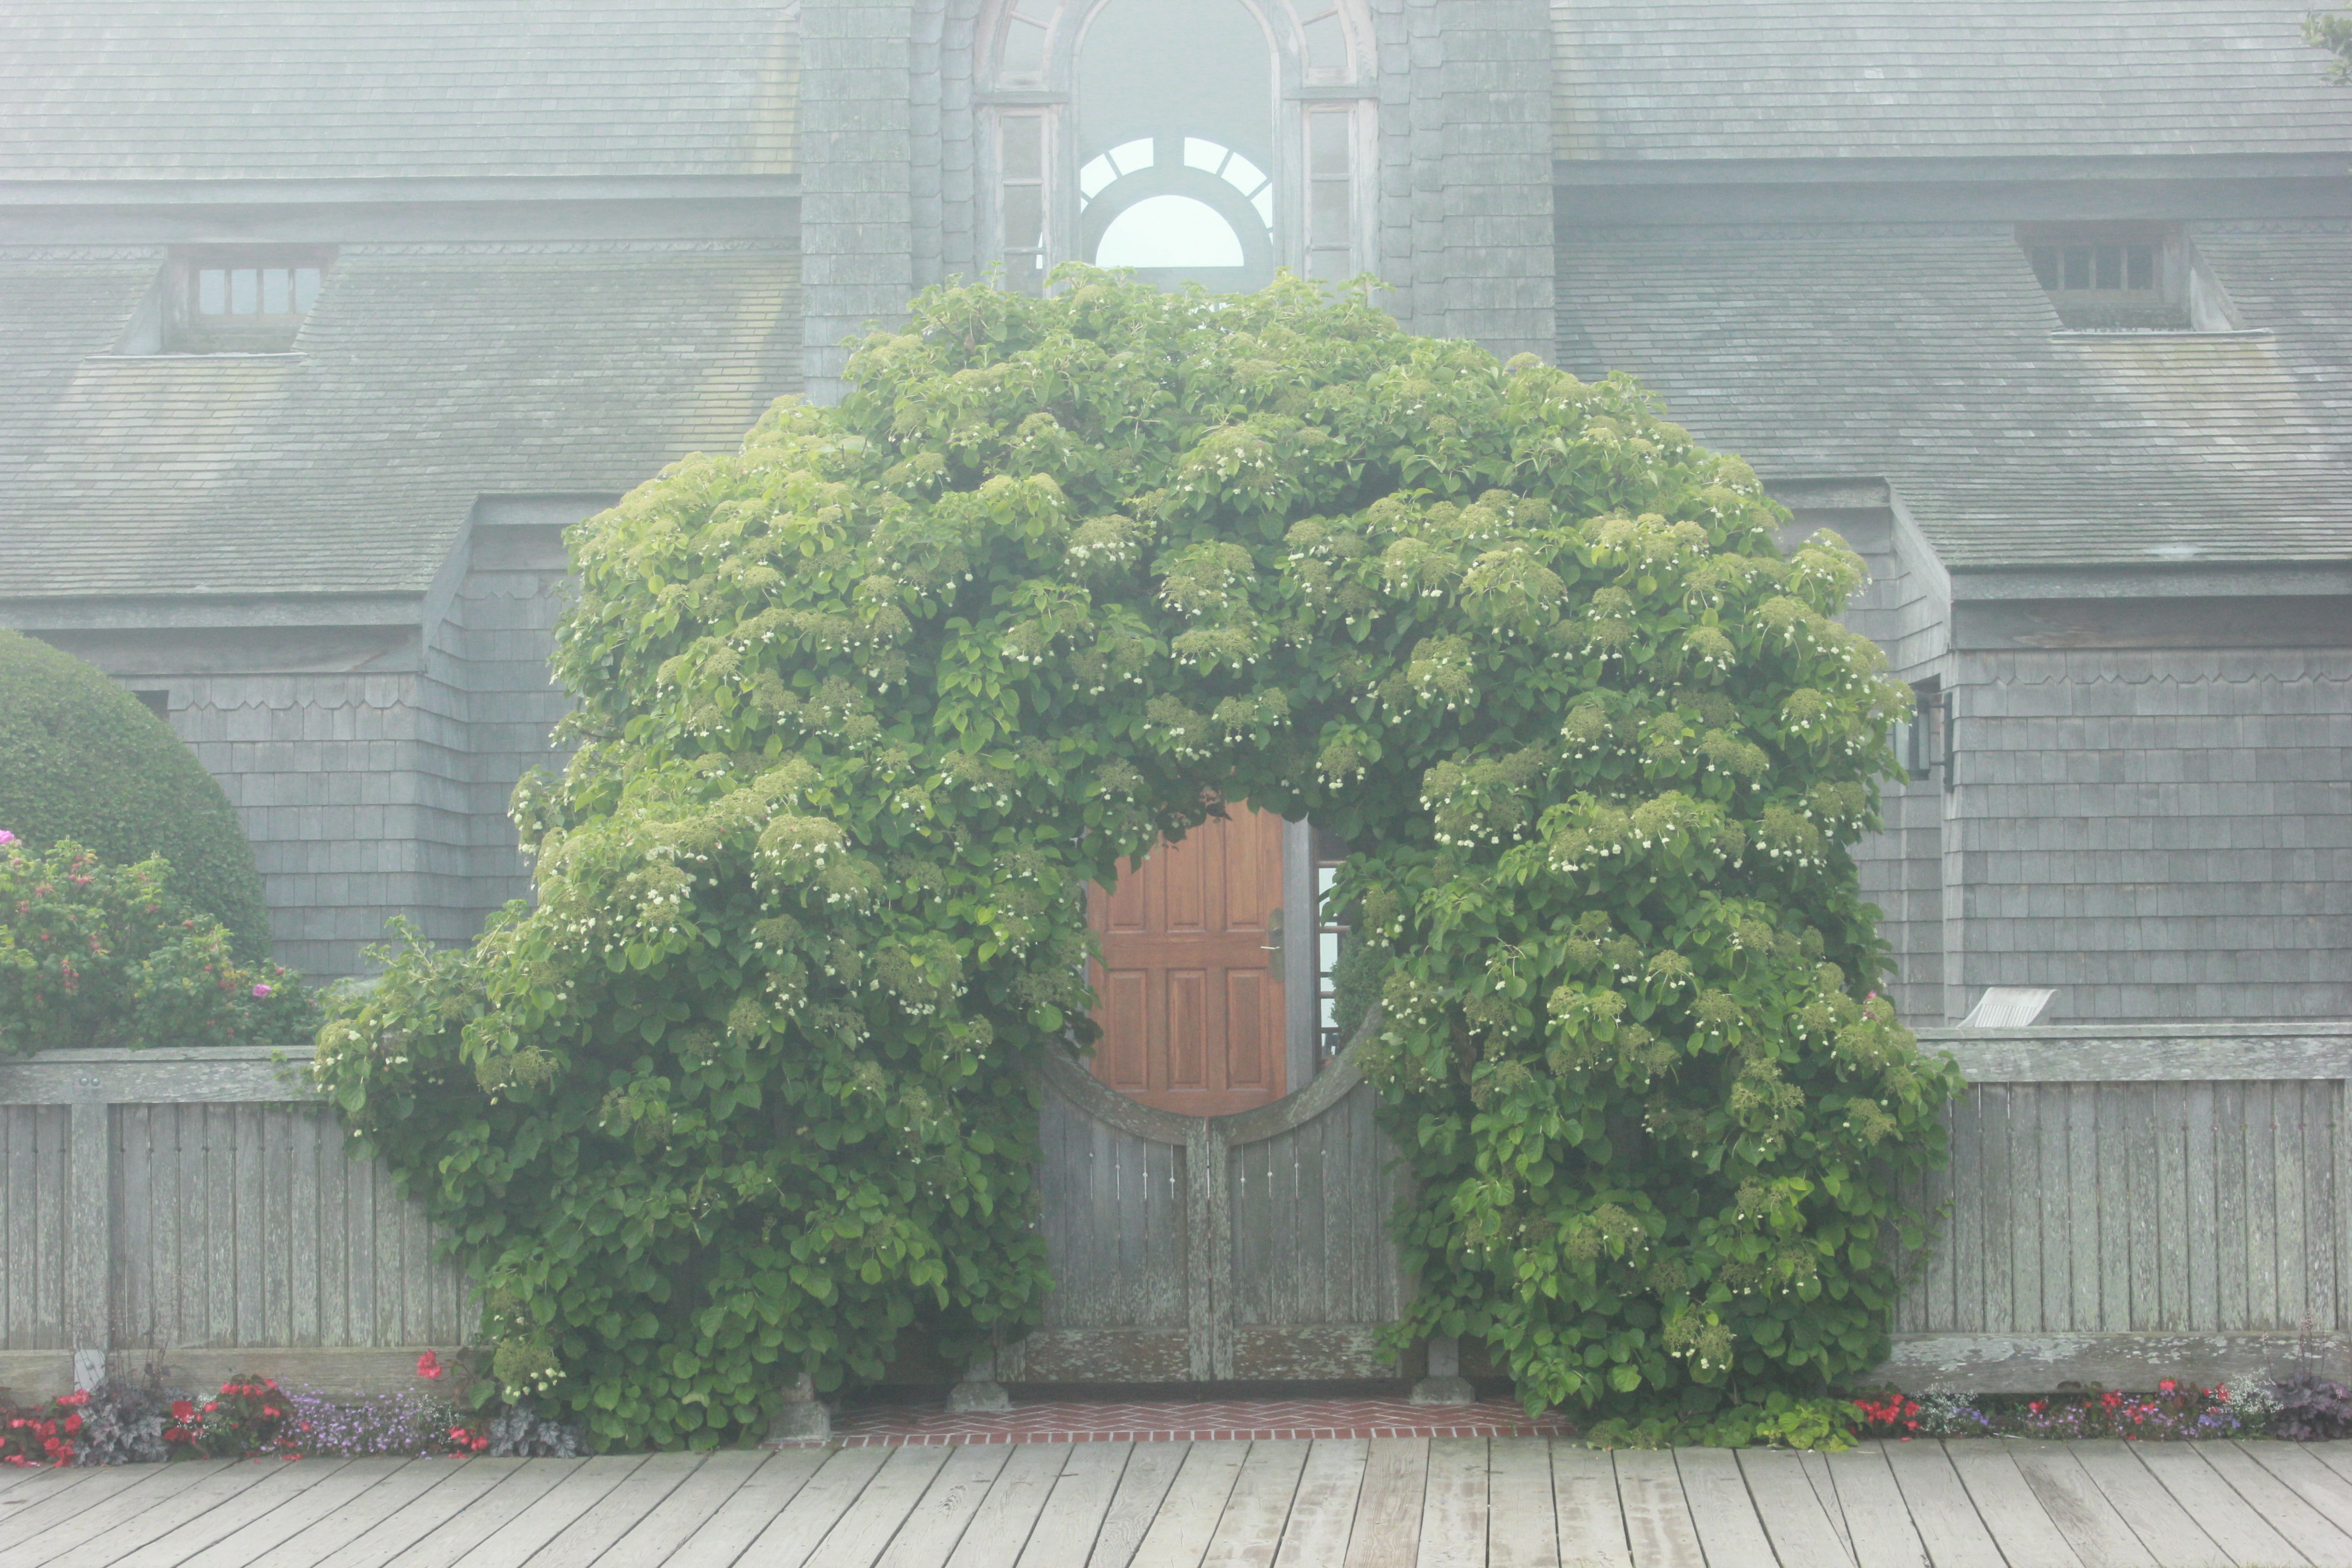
[997,1037,1406,1382]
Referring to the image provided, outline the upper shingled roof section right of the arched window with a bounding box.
[1552,0,2352,160]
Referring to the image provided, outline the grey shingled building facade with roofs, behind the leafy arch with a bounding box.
[0,0,2352,1023]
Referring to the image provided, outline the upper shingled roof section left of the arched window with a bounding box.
[0,0,800,179]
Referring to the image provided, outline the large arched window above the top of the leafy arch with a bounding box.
[981,0,1371,291]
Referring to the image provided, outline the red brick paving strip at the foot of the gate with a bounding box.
[795,1399,1573,1448]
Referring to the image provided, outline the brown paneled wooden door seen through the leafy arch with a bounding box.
[1087,806,1284,1117]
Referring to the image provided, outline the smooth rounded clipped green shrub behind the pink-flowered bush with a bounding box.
[0,632,270,964]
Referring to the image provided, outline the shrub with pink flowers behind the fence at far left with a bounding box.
[0,830,320,1053]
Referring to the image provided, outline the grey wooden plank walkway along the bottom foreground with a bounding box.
[0,1439,2352,1568]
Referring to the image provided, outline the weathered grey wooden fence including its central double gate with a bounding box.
[0,1023,2352,1396]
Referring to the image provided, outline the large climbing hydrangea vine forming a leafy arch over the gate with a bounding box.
[318,268,1950,1446]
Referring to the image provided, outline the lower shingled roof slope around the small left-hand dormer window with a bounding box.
[0,242,800,599]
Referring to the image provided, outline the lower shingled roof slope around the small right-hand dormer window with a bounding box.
[1559,221,2352,567]
